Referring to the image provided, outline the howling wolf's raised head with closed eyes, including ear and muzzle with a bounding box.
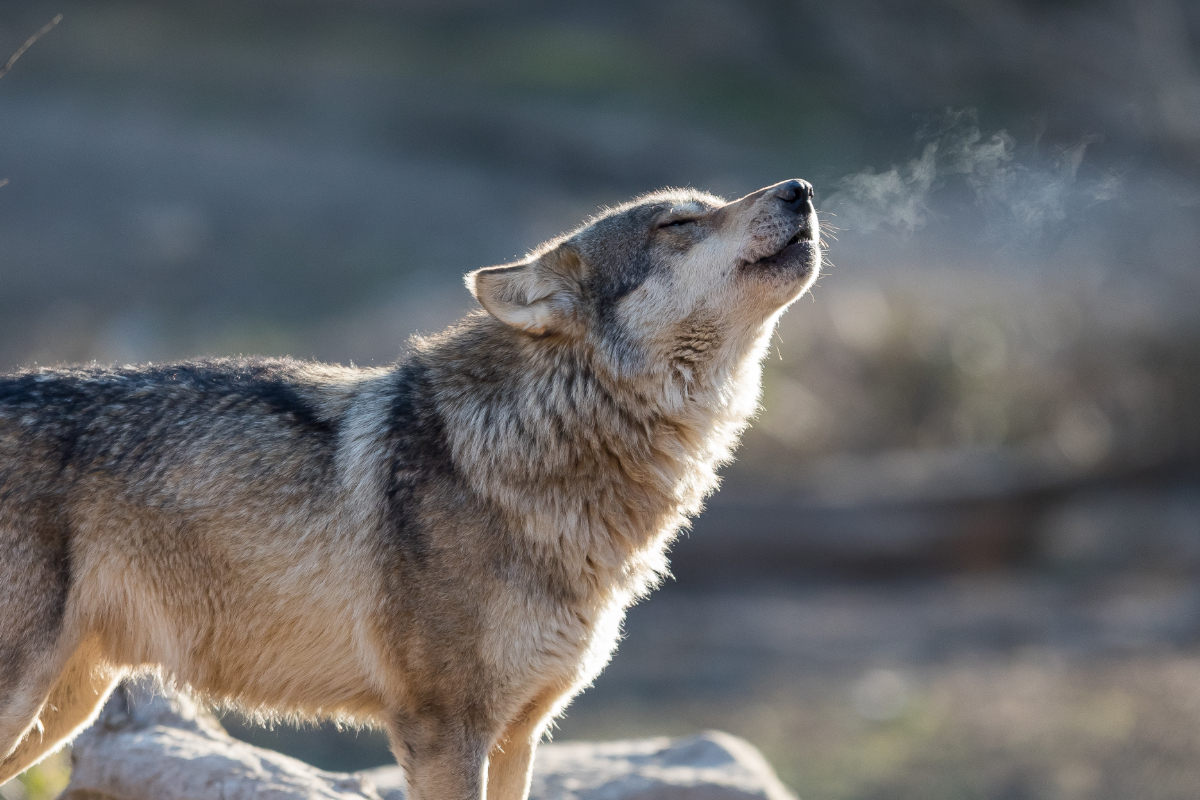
[466,180,821,374]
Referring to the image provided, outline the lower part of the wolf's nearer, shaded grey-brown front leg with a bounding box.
[388,715,493,800]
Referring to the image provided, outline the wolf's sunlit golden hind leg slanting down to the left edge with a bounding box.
[0,642,118,783]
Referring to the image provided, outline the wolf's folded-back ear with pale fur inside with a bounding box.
[466,245,583,336]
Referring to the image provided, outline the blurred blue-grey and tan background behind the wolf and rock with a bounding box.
[0,0,1200,800]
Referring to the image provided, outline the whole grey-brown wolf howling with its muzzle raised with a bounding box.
[0,180,822,800]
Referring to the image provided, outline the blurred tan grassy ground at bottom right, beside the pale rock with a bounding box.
[560,652,1200,800]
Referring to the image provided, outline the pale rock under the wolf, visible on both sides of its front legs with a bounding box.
[61,681,793,800]
